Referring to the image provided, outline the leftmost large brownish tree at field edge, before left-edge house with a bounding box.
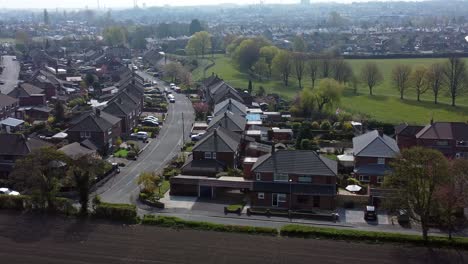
[10,147,69,210]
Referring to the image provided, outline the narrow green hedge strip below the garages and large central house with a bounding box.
[141,215,278,236]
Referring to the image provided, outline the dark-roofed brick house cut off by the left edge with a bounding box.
[0,134,52,179]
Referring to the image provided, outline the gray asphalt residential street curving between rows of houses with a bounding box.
[95,72,195,203]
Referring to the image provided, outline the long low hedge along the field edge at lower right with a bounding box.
[280,224,468,249]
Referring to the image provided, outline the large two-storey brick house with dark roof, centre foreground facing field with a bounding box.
[251,150,337,210]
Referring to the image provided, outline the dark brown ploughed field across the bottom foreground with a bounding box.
[0,213,468,264]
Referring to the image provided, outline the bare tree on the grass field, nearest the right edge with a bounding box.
[444,57,467,106]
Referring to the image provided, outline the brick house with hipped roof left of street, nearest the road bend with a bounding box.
[67,109,122,154]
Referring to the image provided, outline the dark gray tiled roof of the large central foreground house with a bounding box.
[252,150,338,176]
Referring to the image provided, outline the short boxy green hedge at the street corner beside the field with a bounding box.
[94,202,137,224]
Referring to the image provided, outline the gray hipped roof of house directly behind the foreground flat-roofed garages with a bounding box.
[193,127,241,152]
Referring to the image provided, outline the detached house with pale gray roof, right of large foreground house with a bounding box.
[353,130,400,184]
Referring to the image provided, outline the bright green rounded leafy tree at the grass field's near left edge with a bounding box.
[314,79,343,112]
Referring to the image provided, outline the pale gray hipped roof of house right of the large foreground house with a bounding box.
[353,130,400,158]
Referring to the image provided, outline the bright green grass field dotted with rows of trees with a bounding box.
[194,55,468,124]
